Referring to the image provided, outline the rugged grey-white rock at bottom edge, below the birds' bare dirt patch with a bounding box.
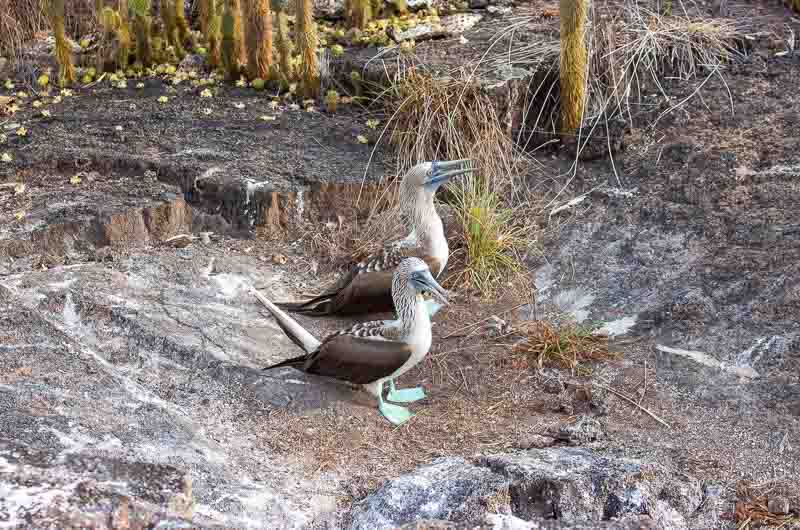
[349,447,714,530]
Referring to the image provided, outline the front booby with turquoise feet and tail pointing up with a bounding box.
[260,257,454,425]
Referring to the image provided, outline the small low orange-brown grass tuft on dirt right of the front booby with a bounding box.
[514,320,621,375]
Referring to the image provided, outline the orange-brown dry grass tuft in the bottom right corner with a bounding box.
[733,480,800,530]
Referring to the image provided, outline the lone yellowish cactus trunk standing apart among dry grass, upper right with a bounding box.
[559,0,589,133]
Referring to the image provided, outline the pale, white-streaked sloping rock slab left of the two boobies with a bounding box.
[0,246,353,528]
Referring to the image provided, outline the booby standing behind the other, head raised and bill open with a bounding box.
[276,159,474,316]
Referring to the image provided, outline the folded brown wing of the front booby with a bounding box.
[304,335,411,385]
